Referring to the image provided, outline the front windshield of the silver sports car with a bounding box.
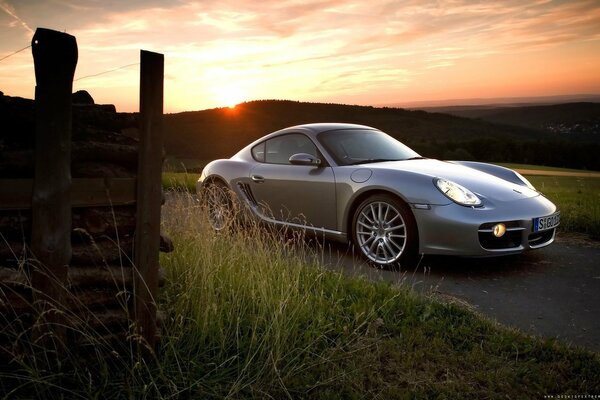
[318,129,420,165]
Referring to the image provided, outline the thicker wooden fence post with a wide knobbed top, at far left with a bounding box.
[31,28,77,346]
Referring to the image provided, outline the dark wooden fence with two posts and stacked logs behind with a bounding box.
[0,28,172,358]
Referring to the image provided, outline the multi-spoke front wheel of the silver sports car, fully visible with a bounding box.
[352,194,418,268]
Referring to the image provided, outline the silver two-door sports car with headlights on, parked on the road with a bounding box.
[197,123,560,267]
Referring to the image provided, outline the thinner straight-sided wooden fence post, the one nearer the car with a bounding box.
[134,50,164,348]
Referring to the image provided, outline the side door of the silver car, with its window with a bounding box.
[250,133,336,230]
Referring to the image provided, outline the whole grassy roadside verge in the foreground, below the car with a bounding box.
[0,194,600,399]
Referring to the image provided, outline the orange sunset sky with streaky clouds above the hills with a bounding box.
[0,0,600,112]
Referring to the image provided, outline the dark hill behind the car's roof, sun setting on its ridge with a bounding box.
[165,100,548,159]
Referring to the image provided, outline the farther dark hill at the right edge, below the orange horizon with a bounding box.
[418,102,600,142]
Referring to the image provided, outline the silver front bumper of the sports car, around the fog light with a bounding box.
[413,195,557,257]
